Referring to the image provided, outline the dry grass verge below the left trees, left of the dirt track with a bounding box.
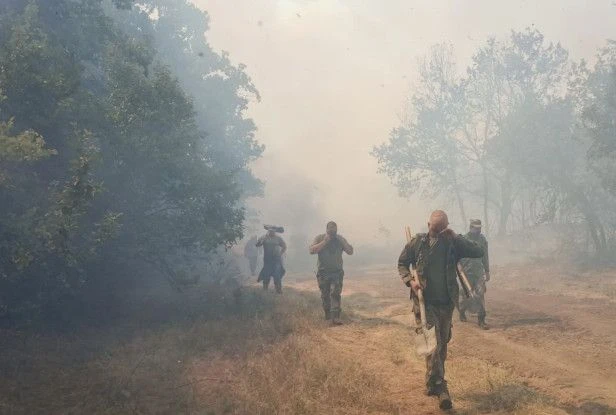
[0,290,404,414]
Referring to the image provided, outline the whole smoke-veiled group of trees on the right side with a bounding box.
[373,29,616,257]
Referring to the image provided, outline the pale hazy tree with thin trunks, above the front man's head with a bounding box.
[373,29,568,234]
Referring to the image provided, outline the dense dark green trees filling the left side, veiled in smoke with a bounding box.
[0,0,263,317]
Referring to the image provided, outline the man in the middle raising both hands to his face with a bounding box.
[310,222,353,326]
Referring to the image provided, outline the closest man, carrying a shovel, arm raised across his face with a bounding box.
[398,210,483,409]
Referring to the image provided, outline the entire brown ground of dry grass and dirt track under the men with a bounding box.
[0,265,616,415]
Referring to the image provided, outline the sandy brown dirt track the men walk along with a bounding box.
[292,269,616,415]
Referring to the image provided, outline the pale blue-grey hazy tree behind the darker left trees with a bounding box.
[108,0,263,196]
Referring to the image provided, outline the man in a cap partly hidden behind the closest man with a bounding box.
[458,219,490,330]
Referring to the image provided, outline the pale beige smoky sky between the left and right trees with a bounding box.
[194,0,616,242]
